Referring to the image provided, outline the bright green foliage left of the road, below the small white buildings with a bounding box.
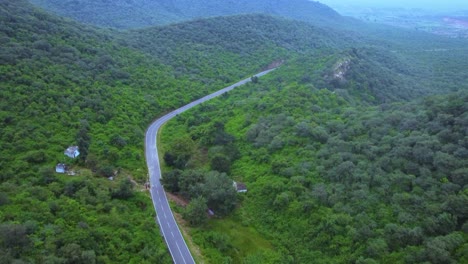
[0,176,171,263]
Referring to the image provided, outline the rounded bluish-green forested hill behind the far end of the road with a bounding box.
[119,14,352,81]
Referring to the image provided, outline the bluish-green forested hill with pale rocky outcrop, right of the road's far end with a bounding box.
[314,43,468,104]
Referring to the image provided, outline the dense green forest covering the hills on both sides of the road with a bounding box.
[0,0,468,263]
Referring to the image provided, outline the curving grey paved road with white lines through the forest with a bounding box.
[145,69,274,264]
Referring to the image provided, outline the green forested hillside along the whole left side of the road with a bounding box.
[0,0,344,263]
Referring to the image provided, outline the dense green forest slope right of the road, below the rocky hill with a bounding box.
[162,58,468,263]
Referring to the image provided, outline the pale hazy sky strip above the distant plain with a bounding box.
[316,0,468,10]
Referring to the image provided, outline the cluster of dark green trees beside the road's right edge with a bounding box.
[162,120,239,226]
